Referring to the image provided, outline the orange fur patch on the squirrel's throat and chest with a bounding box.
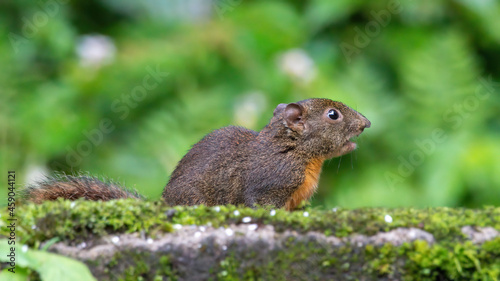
[285,159,324,211]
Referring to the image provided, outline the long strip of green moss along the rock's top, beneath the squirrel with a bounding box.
[0,199,500,245]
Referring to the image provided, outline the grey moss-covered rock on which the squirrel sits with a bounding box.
[0,199,500,280]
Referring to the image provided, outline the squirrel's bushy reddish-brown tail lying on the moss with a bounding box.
[24,175,144,203]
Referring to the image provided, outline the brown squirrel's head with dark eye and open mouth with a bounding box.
[273,99,371,159]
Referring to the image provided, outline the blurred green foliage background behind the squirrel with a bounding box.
[0,0,500,207]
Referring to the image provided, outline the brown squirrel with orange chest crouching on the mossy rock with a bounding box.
[25,98,371,211]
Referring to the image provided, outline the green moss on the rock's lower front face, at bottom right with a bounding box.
[206,239,500,281]
